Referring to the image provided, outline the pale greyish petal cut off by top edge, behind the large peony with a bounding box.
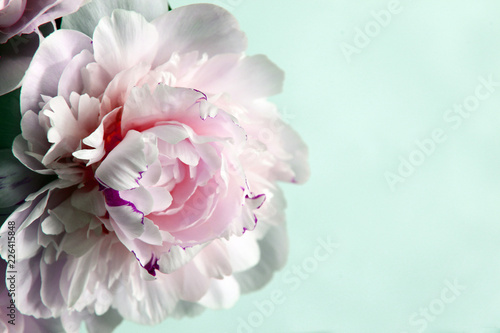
[61,0,170,38]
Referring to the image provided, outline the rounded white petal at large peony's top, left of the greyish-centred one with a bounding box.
[94,9,158,76]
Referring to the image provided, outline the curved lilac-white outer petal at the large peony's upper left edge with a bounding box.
[21,30,92,114]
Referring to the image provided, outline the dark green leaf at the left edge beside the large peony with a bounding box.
[0,89,21,149]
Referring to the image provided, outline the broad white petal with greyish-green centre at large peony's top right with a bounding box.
[152,4,247,67]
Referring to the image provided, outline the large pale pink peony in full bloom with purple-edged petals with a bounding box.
[0,5,309,332]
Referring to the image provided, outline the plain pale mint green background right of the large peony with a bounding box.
[110,0,500,333]
